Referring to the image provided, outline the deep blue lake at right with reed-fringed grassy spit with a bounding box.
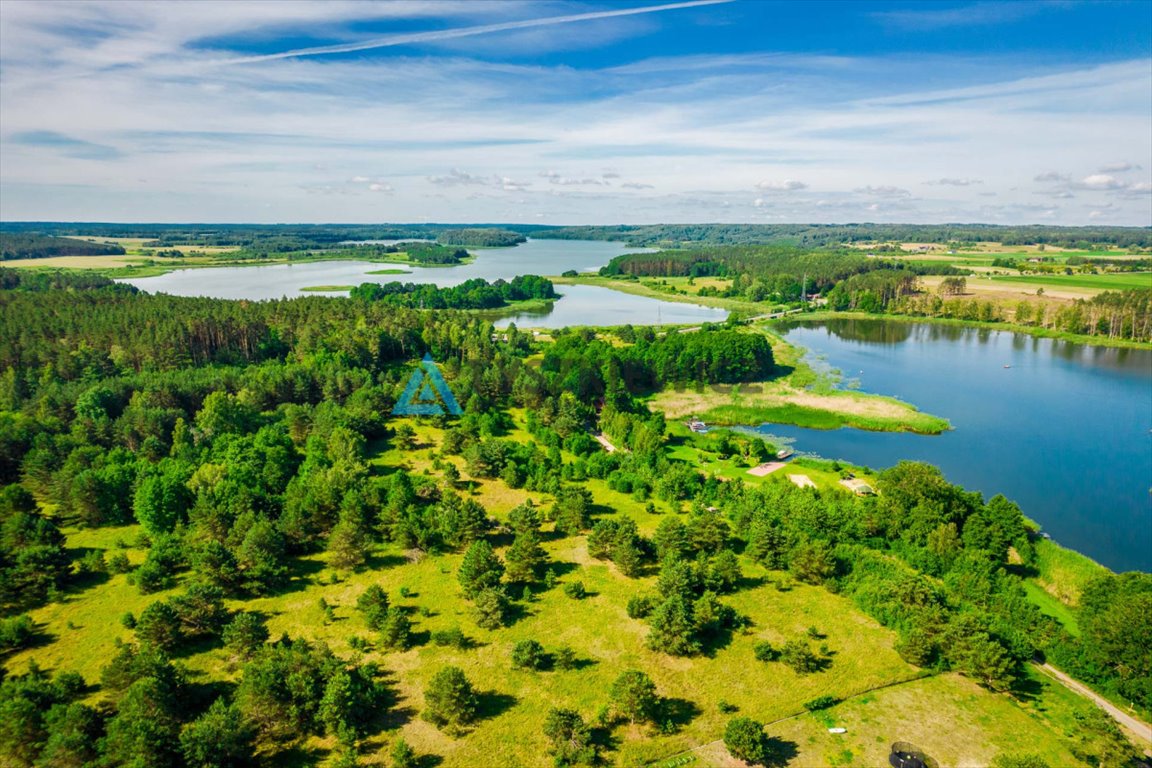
[757,319,1152,571]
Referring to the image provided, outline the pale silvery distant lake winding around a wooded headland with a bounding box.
[121,239,728,328]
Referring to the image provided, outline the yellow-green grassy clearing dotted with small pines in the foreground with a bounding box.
[6,412,1115,768]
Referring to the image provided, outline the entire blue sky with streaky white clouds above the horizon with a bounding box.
[0,0,1152,226]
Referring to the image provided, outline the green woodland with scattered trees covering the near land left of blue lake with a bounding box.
[0,263,1152,768]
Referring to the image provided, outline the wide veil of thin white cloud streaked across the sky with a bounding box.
[0,0,1152,226]
